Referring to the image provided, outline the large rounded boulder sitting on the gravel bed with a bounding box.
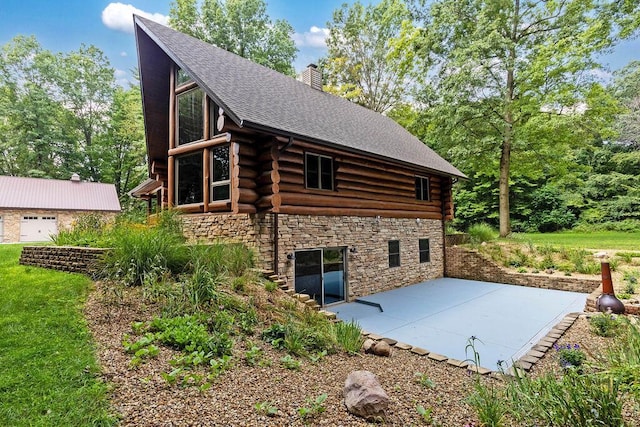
[344,371,389,421]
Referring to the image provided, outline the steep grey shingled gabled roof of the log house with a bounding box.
[134,16,465,177]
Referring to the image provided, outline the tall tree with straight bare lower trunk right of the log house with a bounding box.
[415,0,640,236]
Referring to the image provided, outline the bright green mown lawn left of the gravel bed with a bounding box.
[0,245,115,426]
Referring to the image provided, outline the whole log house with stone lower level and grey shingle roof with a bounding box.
[133,17,464,305]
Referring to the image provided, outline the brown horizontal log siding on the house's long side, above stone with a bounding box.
[256,141,452,219]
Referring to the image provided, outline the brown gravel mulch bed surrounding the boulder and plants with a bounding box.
[85,283,640,427]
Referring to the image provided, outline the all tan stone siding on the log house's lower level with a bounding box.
[182,214,444,300]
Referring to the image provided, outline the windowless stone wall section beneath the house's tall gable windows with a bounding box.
[181,213,273,269]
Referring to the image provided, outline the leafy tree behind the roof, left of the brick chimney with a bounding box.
[169,0,298,75]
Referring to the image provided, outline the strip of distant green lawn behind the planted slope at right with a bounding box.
[507,231,640,251]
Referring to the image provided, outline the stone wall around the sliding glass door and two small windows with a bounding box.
[279,214,444,301]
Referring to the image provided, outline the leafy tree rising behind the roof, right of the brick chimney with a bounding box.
[322,0,420,113]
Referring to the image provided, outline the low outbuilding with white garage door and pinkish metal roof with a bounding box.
[0,174,120,243]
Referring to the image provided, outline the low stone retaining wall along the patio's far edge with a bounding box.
[445,246,600,293]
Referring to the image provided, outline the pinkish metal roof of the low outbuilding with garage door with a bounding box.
[0,176,121,212]
